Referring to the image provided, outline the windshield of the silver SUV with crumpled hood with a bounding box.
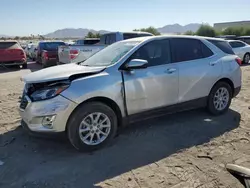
[81,41,139,66]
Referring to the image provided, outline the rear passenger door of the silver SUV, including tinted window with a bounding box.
[171,38,222,103]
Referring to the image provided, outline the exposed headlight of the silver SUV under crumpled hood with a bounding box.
[30,81,69,101]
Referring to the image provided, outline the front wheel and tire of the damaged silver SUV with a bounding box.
[67,102,117,151]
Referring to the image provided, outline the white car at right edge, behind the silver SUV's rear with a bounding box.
[228,40,250,64]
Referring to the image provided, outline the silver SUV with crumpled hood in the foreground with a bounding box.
[20,36,241,151]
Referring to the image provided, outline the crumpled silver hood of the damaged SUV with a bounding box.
[21,63,105,83]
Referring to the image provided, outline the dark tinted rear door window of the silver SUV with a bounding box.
[171,38,203,62]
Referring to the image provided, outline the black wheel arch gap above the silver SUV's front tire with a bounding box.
[65,97,123,132]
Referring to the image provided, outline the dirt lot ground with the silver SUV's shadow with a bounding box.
[0,64,250,188]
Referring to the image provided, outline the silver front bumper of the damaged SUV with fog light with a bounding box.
[19,95,77,133]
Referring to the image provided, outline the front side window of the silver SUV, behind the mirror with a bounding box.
[130,40,171,67]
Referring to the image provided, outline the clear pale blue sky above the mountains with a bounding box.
[0,0,250,36]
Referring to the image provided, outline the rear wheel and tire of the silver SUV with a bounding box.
[207,82,233,115]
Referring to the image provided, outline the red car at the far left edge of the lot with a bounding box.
[0,41,27,68]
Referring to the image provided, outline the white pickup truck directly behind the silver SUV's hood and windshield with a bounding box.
[58,32,153,64]
